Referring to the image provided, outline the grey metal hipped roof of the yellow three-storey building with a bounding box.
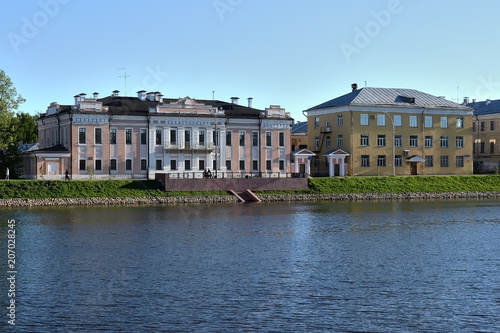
[307,87,470,111]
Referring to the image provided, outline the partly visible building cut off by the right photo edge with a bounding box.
[470,100,500,173]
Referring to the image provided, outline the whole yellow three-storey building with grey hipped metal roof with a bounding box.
[304,84,473,176]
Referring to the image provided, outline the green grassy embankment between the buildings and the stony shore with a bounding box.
[0,175,500,199]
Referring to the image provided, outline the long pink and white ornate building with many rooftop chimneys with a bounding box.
[28,90,293,179]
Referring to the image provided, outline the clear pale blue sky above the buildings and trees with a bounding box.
[0,0,500,121]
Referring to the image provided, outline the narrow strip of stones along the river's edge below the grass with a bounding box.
[0,192,500,207]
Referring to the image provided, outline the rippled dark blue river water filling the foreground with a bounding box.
[0,201,500,332]
